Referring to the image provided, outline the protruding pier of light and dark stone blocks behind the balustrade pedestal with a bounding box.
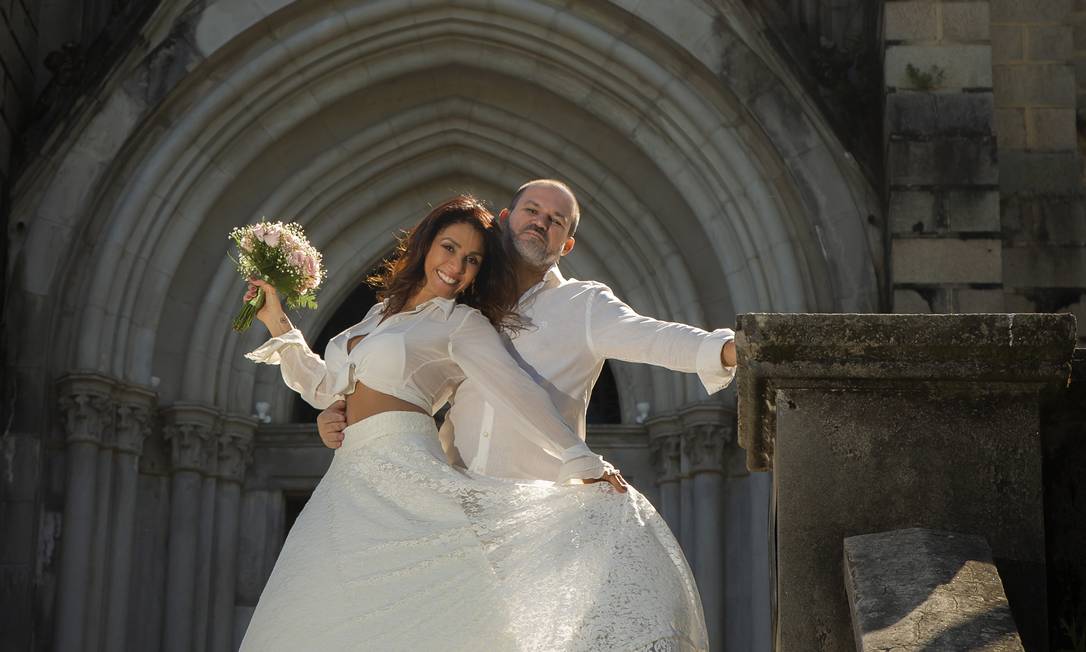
[883,0,1003,313]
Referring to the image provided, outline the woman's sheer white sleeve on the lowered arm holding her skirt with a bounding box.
[449,310,613,482]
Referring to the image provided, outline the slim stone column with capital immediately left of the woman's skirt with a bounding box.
[207,416,256,652]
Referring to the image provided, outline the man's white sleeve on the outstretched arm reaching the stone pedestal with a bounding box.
[585,286,735,394]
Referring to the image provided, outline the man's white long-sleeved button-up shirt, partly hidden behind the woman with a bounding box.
[441,265,735,479]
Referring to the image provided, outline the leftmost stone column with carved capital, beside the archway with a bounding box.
[54,374,114,652]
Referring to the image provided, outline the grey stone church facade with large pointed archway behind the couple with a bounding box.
[0,0,1086,651]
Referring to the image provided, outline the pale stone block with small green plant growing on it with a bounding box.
[884,45,992,90]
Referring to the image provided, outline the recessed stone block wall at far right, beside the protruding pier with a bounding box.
[992,0,1086,334]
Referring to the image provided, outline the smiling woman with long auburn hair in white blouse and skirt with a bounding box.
[241,196,708,651]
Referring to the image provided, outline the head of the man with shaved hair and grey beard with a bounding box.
[502,184,577,268]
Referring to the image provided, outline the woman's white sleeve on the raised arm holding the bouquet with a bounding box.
[245,328,350,410]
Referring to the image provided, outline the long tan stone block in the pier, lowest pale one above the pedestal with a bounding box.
[891,238,1002,284]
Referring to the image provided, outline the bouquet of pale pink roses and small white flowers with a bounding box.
[230,222,325,333]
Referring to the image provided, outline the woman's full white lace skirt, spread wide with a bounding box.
[241,412,708,652]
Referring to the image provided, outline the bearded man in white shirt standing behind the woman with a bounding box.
[317,179,735,491]
